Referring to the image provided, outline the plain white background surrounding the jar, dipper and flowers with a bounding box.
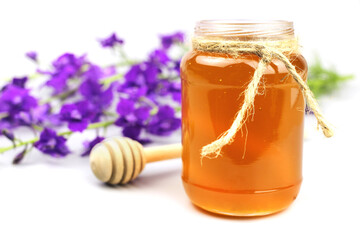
[0,0,360,239]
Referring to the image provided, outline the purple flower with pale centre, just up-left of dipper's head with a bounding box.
[60,101,94,132]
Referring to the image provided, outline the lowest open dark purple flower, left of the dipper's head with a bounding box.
[34,128,70,157]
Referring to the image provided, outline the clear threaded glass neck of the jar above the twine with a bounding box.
[195,20,294,41]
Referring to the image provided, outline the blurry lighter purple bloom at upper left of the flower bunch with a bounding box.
[43,53,87,93]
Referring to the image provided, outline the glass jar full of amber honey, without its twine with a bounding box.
[181,20,307,216]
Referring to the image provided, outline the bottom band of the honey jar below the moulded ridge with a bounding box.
[183,180,301,217]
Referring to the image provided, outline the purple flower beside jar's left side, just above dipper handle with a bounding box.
[146,105,181,136]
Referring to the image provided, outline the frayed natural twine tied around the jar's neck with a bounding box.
[193,38,334,158]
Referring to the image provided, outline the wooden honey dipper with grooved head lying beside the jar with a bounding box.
[90,137,182,184]
